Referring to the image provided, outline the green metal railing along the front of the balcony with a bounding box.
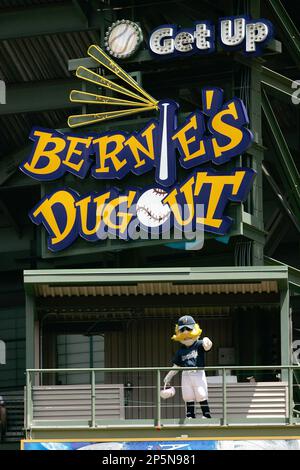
[25,365,300,430]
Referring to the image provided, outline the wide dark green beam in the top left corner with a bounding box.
[0,2,101,41]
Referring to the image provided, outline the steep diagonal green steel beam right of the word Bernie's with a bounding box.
[262,92,300,219]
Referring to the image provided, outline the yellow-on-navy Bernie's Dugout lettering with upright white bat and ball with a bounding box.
[20,88,255,251]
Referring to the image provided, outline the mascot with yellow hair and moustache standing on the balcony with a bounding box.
[164,315,212,418]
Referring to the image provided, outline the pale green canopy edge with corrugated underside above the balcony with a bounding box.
[24,265,288,298]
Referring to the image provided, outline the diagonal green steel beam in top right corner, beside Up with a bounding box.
[269,0,300,67]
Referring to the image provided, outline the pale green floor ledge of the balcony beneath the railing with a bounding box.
[27,418,300,441]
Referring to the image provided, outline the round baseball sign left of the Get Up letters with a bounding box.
[105,20,143,59]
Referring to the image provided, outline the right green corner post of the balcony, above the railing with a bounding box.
[280,283,291,381]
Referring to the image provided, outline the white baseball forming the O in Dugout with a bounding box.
[136,188,171,227]
